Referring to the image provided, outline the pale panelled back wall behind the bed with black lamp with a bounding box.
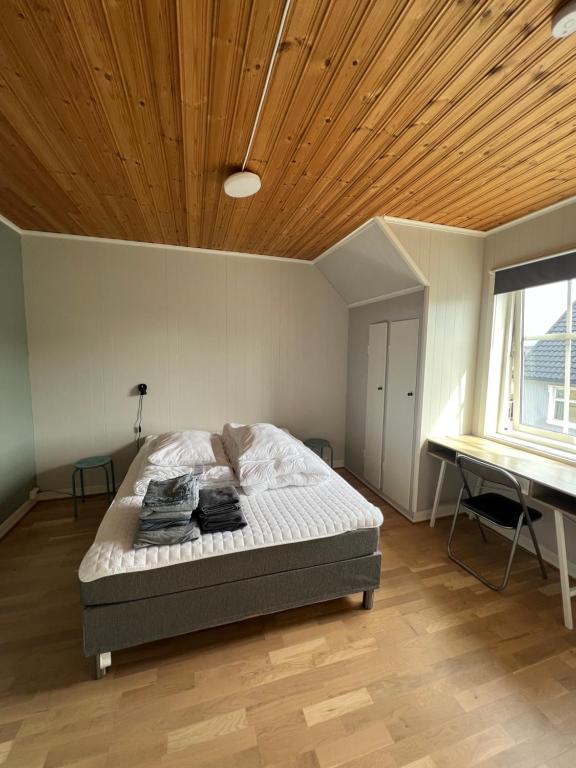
[22,234,348,488]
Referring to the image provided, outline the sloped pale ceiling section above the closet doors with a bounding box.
[315,219,424,305]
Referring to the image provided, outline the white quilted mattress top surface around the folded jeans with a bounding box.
[79,441,383,582]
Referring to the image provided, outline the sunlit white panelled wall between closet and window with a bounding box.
[388,221,484,519]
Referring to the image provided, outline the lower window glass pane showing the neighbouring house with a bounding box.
[520,340,567,432]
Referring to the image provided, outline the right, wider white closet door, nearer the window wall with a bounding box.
[382,320,420,510]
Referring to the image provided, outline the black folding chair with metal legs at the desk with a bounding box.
[448,455,547,592]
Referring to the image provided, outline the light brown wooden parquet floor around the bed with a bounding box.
[0,472,576,768]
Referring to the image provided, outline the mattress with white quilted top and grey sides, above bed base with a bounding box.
[79,441,383,592]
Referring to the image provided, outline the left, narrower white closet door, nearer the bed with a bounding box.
[364,323,388,488]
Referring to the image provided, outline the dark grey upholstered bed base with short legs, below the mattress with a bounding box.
[83,529,381,677]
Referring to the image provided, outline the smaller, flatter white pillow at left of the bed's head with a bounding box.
[148,429,228,467]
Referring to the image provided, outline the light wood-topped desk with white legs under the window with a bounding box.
[427,435,576,629]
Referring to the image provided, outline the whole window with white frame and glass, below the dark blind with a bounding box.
[497,280,576,449]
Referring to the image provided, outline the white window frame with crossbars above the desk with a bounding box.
[497,280,576,453]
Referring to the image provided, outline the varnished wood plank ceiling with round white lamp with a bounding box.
[0,0,576,259]
